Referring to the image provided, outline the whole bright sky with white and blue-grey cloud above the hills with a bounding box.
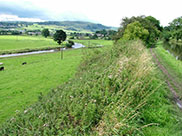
[0,0,182,27]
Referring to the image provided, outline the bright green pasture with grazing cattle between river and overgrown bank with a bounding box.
[0,49,82,123]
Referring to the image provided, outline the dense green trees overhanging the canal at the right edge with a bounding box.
[163,17,182,60]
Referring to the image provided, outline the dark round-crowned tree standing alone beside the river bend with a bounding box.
[53,30,66,45]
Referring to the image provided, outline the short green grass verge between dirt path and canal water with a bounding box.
[155,42,182,94]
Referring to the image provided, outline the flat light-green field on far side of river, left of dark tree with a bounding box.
[0,35,58,52]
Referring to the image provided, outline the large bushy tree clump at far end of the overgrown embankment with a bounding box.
[115,16,162,47]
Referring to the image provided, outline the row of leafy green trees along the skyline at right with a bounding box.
[113,16,182,60]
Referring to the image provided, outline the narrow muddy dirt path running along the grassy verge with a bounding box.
[150,48,182,110]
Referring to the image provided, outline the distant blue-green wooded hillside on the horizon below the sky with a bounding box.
[0,21,117,32]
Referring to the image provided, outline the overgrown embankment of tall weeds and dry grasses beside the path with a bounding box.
[0,41,179,135]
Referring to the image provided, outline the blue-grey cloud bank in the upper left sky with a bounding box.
[0,0,94,22]
